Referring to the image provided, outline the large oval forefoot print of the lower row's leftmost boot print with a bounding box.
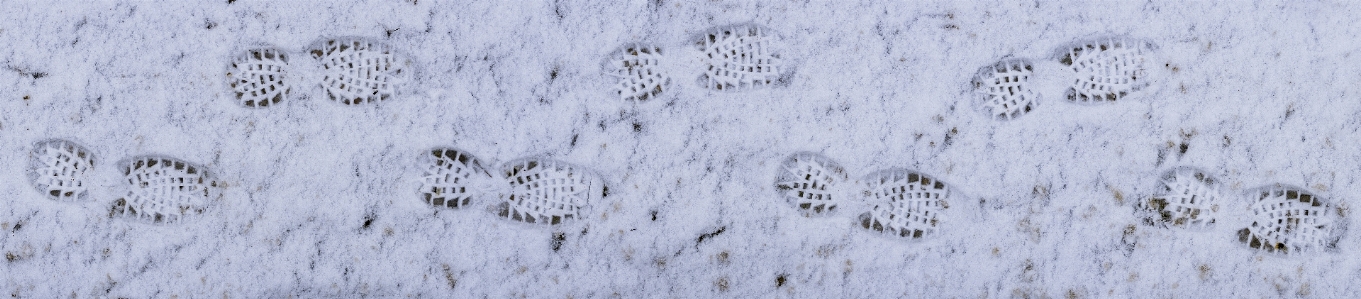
[110,156,218,223]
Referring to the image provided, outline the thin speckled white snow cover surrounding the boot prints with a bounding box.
[0,0,1361,298]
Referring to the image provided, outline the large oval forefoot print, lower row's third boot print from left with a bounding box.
[860,169,950,239]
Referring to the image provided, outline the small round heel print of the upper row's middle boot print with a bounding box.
[606,45,671,101]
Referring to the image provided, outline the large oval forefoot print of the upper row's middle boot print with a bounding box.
[697,24,789,90]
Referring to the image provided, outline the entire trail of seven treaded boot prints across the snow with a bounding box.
[10,24,1346,253]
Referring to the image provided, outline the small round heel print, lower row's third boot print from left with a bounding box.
[774,152,853,216]
